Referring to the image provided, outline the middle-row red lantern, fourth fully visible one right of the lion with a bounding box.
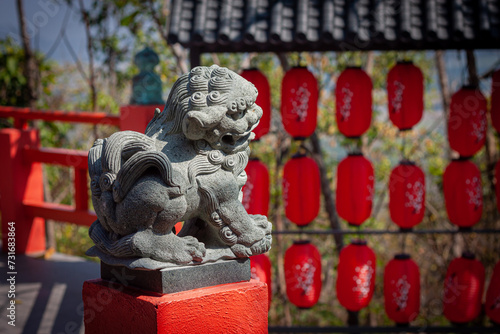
[443,159,483,227]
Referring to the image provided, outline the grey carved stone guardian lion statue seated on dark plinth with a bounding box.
[88,65,271,269]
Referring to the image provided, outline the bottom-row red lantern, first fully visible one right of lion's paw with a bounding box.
[285,241,321,308]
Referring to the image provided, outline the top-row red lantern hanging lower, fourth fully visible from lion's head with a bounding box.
[448,86,487,157]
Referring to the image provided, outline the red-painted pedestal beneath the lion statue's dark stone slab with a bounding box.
[83,279,268,334]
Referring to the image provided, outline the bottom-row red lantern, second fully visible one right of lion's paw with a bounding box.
[337,240,376,312]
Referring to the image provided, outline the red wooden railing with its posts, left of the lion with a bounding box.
[0,106,163,253]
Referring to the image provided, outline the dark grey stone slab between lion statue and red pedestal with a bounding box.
[101,258,250,294]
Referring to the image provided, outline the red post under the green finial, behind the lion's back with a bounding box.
[120,105,163,133]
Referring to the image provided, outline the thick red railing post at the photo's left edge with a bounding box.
[0,129,45,254]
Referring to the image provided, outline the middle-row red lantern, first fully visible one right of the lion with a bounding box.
[283,155,321,226]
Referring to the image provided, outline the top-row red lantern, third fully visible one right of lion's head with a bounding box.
[387,62,424,131]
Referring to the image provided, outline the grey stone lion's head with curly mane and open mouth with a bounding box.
[146,65,262,154]
